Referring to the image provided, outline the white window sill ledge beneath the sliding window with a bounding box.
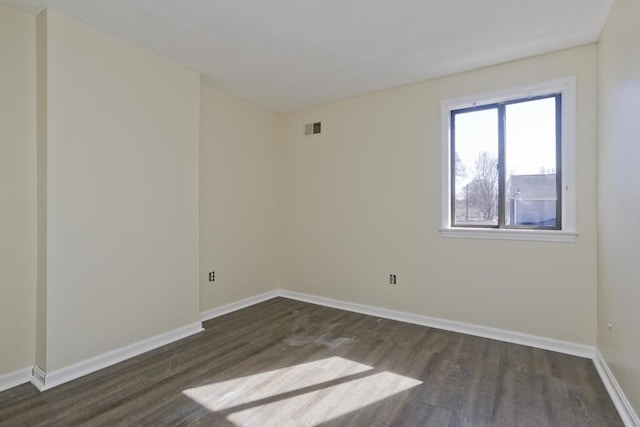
[440,227,578,243]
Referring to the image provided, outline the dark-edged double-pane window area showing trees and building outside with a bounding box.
[451,95,561,229]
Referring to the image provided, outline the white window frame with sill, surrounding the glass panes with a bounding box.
[440,77,578,243]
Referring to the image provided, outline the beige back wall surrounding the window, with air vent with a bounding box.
[281,45,597,345]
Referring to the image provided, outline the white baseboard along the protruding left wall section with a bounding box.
[31,322,204,391]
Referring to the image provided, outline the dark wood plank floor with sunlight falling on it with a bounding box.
[0,298,623,427]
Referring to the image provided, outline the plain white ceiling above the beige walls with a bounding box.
[0,0,613,112]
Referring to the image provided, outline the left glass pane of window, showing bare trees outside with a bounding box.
[454,108,498,226]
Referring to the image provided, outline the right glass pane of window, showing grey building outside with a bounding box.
[505,97,558,227]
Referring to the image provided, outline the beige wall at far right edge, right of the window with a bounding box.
[598,0,640,414]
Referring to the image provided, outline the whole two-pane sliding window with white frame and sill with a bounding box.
[442,79,576,241]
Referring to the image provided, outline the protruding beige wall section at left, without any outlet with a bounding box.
[46,11,200,371]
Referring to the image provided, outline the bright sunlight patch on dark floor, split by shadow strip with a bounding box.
[183,357,422,427]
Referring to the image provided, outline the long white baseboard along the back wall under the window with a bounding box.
[279,290,595,359]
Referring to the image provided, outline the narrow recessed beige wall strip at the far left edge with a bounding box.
[0,5,37,377]
